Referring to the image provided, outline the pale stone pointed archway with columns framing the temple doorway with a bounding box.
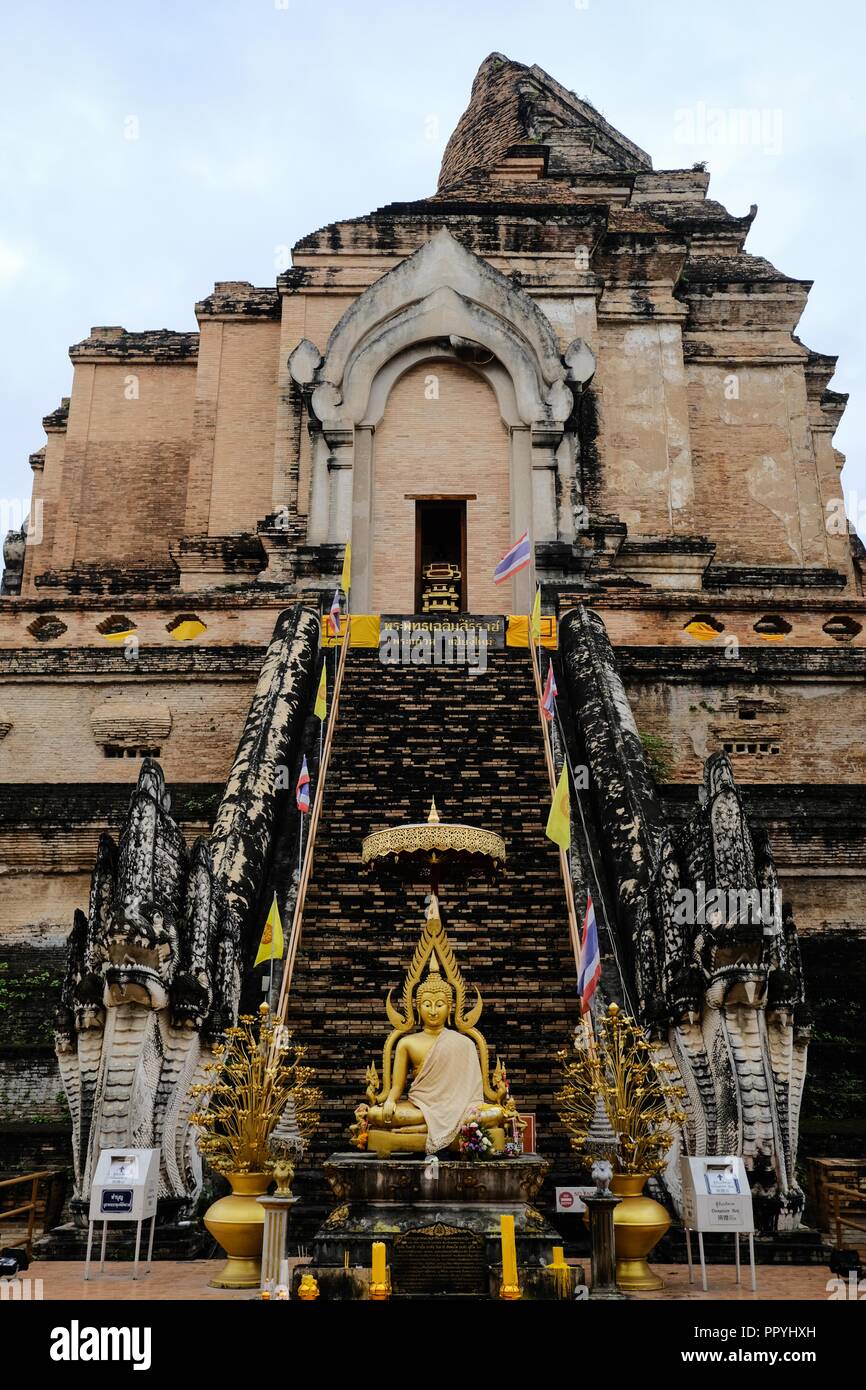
[289,228,583,610]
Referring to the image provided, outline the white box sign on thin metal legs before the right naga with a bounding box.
[680,1155,758,1293]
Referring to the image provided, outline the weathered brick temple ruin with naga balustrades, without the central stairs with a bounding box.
[0,54,866,1228]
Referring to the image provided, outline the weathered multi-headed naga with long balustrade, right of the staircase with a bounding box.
[560,607,808,1229]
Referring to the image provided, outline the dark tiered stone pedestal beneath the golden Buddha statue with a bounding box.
[297,1154,580,1300]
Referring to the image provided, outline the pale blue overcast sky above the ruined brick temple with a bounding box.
[0,0,866,539]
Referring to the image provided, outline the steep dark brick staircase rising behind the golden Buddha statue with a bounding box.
[289,648,578,1223]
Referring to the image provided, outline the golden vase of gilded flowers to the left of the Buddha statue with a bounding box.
[190,1004,321,1289]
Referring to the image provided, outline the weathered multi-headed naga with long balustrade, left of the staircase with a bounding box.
[56,607,318,1220]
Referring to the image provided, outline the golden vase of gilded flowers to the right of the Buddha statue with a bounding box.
[556,1004,687,1291]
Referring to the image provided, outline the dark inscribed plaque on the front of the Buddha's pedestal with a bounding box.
[391,1222,488,1294]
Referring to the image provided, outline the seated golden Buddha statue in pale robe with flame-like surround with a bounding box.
[350,895,523,1154]
